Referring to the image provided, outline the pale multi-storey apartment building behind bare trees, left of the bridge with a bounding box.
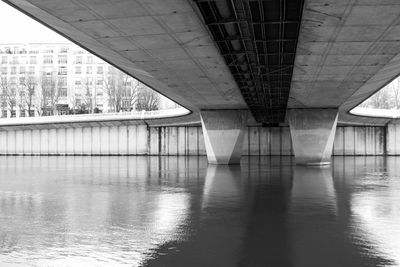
[0,43,176,117]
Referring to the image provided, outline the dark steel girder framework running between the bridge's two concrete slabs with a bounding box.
[195,0,303,124]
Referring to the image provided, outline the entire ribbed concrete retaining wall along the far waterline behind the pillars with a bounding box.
[0,125,394,156]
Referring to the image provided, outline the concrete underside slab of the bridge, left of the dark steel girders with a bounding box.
[5,0,246,111]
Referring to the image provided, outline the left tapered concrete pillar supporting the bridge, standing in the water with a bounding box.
[200,110,248,164]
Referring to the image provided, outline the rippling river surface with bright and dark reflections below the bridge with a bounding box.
[0,157,400,266]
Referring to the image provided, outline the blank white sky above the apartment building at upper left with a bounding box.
[0,1,69,43]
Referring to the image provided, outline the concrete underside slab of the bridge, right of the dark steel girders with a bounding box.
[288,0,400,125]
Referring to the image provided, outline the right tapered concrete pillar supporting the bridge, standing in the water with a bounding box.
[288,108,338,165]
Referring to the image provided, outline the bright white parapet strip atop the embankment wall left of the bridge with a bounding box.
[0,108,190,126]
